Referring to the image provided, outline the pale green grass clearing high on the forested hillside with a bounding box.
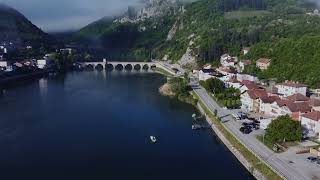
[224,10,270,19]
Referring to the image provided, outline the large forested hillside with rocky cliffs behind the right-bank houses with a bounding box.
[74,0,320,86]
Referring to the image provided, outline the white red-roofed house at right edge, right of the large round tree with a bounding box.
[301,111,320,139]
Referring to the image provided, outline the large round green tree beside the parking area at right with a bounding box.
[266,115,302,143]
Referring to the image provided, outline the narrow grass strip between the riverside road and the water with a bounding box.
[193,92,282,180]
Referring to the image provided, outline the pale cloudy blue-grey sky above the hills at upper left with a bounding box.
[0,0,139,32]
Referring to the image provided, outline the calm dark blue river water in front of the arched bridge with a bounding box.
[0,72,252,180]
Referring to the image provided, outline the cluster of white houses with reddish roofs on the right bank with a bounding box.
[194,49,320,139]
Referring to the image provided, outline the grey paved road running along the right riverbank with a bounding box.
[192,85,312,180]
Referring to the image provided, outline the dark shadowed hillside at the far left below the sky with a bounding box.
[0,4,50,46]
